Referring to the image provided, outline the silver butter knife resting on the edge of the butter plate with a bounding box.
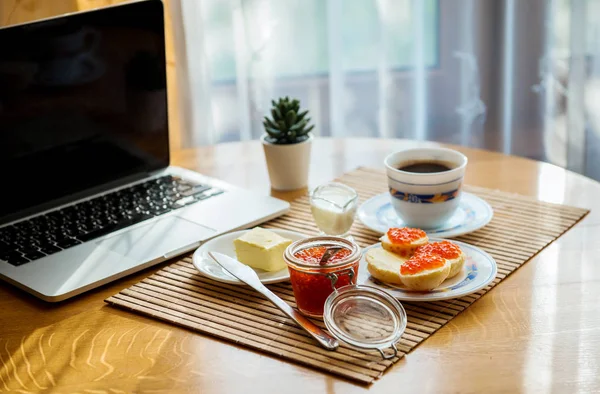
[208,252,339,350]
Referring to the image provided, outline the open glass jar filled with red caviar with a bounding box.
[284,236,361,317]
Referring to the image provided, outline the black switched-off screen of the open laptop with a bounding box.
[0,0,169,218]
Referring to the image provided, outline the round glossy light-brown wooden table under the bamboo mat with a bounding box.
[0,139,600,393]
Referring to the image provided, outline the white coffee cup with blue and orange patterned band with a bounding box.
[385,148,468,229]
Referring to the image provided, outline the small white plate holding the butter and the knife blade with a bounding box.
[192,228,308,285]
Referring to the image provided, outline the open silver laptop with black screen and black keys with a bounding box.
[0,0,289,302]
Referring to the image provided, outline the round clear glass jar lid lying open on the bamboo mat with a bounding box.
[323,285,407,359]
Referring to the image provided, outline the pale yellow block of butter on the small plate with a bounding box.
[233,227,292,271]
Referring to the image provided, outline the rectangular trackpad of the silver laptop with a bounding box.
[98,216,216,262]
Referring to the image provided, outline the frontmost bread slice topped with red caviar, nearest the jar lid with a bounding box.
[399,253,451,291]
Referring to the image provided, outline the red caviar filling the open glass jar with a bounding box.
[286,244,360,317]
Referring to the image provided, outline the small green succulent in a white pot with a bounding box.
[261,97,314,190]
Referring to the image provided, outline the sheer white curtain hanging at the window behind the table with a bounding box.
[170,0,600,179]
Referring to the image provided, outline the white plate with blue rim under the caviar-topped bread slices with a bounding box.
[358,238,498,301]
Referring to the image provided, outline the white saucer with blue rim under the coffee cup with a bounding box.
[358,192,494,238]
